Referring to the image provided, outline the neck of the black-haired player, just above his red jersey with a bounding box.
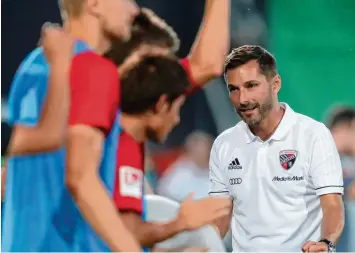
[120,114,146,142]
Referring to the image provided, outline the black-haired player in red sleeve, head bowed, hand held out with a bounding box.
[114,57,230,247]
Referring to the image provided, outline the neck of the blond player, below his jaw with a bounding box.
[64,16,110,55]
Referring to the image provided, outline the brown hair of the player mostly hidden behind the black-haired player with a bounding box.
[105,8,180,66]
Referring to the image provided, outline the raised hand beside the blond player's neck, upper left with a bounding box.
[41,23,74,64]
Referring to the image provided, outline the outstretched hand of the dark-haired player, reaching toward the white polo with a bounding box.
[177,194,232,230]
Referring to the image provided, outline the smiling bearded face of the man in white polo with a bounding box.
[227,61,279,127]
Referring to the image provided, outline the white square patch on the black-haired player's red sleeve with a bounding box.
[119,166,144,198]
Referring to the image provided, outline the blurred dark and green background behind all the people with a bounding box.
[1,0,355,252]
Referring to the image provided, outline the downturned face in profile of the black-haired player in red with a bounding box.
[147,96,185,143]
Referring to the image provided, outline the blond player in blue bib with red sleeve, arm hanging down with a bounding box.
[2,0,140,251]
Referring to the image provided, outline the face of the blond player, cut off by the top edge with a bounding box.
[93,0,138,41]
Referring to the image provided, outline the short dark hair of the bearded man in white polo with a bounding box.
[224,45,277,78]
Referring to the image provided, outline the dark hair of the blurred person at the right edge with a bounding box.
[328,106,355,129]
